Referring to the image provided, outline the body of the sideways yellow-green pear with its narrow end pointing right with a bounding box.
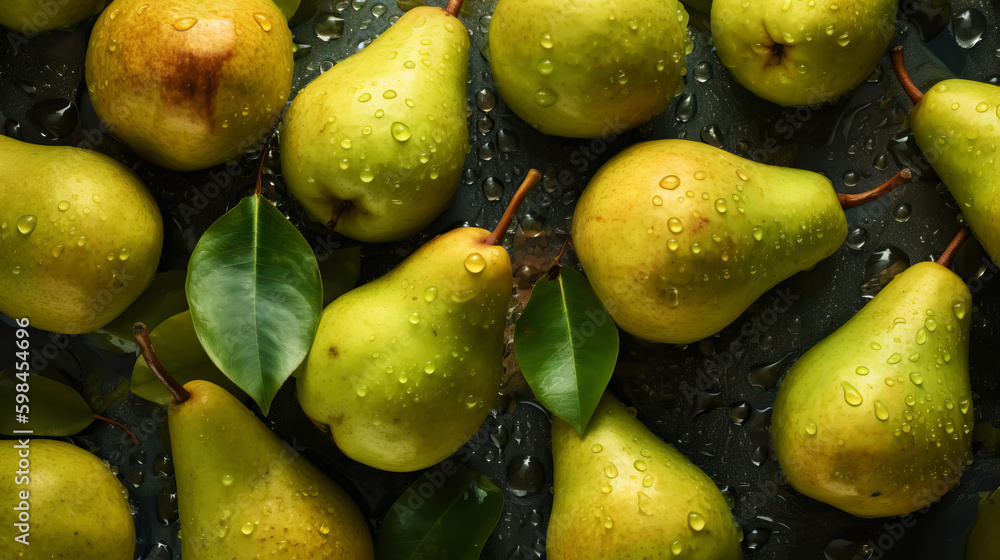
[572,140,847,344]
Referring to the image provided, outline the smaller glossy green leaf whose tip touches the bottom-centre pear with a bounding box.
[514,267,618,434]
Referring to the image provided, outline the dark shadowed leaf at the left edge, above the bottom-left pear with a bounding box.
[0,369,94,437]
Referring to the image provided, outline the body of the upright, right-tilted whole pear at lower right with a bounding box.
[771,262,974,517]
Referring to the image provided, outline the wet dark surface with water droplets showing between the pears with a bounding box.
[0,0,1000,560]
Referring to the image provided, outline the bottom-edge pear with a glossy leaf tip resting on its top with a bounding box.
[545,393,743,560]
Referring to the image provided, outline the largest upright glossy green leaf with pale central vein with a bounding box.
[187,194,323,414]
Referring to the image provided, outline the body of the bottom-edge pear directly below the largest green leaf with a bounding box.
[168,381,374,560]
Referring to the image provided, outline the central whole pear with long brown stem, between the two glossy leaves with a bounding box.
[298,170,540,472]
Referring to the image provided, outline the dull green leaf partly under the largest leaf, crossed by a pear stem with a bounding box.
[129,311,245,404]
